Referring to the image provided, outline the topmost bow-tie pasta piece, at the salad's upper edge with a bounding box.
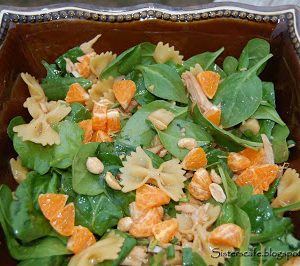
[153,42,183,64]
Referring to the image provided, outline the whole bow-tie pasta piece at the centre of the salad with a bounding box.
[120,147,186,201]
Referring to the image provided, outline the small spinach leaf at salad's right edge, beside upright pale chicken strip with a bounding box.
[271,125,290,163]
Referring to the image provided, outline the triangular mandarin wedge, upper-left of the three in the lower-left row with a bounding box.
[38,193,68,220]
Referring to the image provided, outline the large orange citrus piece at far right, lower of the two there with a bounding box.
[235,164,279,194]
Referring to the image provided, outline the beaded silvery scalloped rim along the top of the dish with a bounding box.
[0,3,300,58]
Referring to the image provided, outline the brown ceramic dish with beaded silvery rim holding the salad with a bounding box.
[0,1,300,266]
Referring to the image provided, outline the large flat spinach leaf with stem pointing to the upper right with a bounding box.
[214,55,272,128]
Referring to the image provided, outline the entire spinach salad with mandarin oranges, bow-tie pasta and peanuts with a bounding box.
[0,35,300,266]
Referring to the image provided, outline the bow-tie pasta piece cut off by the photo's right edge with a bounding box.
[272,168,300,211]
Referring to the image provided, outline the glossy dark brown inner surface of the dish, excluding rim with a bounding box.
[0,18,300,266]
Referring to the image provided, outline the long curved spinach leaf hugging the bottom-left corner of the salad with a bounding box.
[0,185,71,260]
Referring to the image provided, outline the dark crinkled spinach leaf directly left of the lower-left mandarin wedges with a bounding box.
[10,172,58,242]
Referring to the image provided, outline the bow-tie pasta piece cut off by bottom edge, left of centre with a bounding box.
[68,232,125,266]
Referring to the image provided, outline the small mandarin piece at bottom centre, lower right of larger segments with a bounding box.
[152,219,178,244]
